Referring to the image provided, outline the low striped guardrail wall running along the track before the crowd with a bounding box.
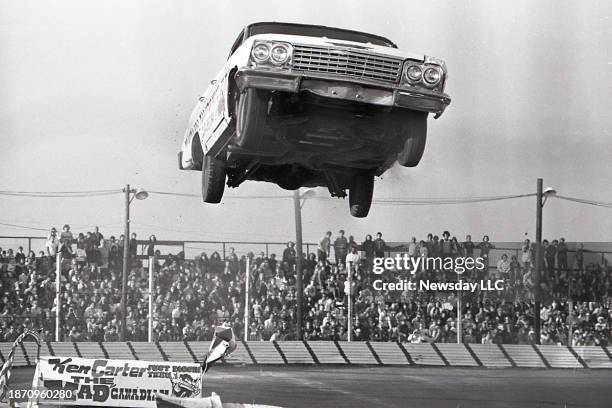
[0,341,612,369]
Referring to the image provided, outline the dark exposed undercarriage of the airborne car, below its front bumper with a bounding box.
[227,89,427,197]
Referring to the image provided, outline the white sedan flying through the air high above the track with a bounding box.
[179,23,450,217]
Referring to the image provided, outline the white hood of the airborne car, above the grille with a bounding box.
[247,34,425,61]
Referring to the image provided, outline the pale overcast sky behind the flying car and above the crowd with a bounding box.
[0,0,612,250]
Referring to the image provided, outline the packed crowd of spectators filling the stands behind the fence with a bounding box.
[0,225,612,345]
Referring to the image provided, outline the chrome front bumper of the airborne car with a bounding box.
[235,69,451,118]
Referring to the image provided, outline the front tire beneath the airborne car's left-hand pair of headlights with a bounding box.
[236,88,268,149]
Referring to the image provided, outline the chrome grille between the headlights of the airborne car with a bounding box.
[293,45,402,83]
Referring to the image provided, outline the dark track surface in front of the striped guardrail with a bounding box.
[11,366,612,408]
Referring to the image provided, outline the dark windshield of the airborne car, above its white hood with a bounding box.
[247,23,397,48]
